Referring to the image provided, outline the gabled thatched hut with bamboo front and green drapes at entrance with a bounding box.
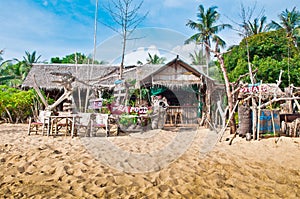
[109,57,225,126]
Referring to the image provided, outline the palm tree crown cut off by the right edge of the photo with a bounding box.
[268,7,300,46]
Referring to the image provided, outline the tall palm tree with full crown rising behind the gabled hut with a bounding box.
[185,5,231,73]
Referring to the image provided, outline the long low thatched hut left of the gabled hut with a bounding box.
[22,63,118,109]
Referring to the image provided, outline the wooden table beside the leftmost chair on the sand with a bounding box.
[47,114,79,137]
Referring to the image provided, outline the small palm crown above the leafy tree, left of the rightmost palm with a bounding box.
[242,16,267,36]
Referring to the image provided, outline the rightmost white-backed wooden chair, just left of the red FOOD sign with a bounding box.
[91,113,109,137]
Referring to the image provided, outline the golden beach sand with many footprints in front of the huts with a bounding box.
[0,124,300,198]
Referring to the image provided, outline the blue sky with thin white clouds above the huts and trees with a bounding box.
[0,0,300,61]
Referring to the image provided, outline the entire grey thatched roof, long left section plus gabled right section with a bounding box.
[22,57,214,89]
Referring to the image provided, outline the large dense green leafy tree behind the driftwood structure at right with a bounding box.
[224,30,300,87]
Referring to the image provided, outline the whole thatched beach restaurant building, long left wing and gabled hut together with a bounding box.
[22,57,225,125]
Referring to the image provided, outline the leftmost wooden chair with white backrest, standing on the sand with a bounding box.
[28,110,52,135]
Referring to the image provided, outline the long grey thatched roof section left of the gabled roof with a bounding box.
[22,64,119,89]
